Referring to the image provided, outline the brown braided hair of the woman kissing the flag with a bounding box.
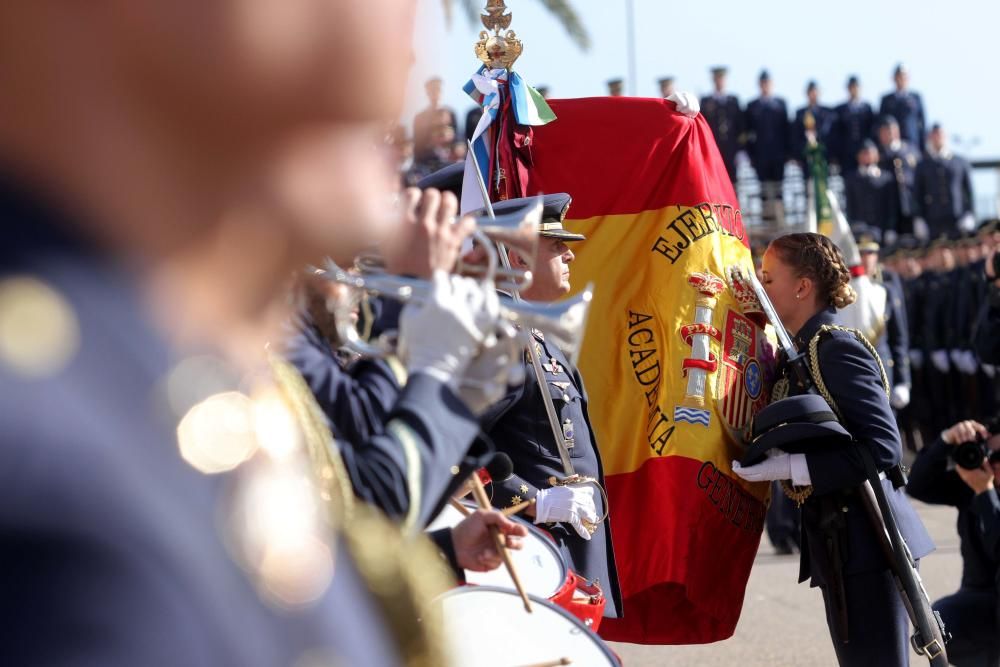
[771,233,858,308]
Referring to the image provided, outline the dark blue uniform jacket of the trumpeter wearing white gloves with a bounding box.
[285,306,491,526]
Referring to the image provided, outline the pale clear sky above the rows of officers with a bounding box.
[404,0,1000,158]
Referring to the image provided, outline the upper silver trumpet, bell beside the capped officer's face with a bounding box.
[355,197,543,291]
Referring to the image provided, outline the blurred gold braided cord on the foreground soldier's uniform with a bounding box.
[270,355,454,667]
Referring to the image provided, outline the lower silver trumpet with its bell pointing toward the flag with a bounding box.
[321,257,594,363]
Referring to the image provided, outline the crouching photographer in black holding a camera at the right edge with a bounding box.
[907,419,1000,665]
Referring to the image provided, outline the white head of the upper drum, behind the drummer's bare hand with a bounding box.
[428,505,569,598]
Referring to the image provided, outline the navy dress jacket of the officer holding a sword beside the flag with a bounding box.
[482,337,622,617]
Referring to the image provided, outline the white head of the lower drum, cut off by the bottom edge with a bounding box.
[433,586,619,667]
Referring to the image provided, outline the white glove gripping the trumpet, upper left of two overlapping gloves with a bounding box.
[399,270,499,387]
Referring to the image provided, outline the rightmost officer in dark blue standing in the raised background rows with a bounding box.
[914,124,975,238]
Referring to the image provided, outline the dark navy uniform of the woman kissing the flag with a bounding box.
[780,308,933,665]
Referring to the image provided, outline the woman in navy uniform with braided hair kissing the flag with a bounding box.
[733,234,933,665]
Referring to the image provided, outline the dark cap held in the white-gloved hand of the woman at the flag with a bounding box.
[741,394,851,465]
